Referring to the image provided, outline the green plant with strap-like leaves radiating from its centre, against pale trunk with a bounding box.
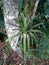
[15,13,43,52]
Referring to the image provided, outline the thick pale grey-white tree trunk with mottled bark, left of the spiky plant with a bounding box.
[2,0,19,52]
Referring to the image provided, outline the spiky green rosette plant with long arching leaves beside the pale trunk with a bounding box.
[6,13,46,57]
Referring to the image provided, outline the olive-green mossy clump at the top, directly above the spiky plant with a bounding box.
[24,0,34,16]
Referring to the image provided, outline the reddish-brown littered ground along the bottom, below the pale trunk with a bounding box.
[0,32,49,65]
